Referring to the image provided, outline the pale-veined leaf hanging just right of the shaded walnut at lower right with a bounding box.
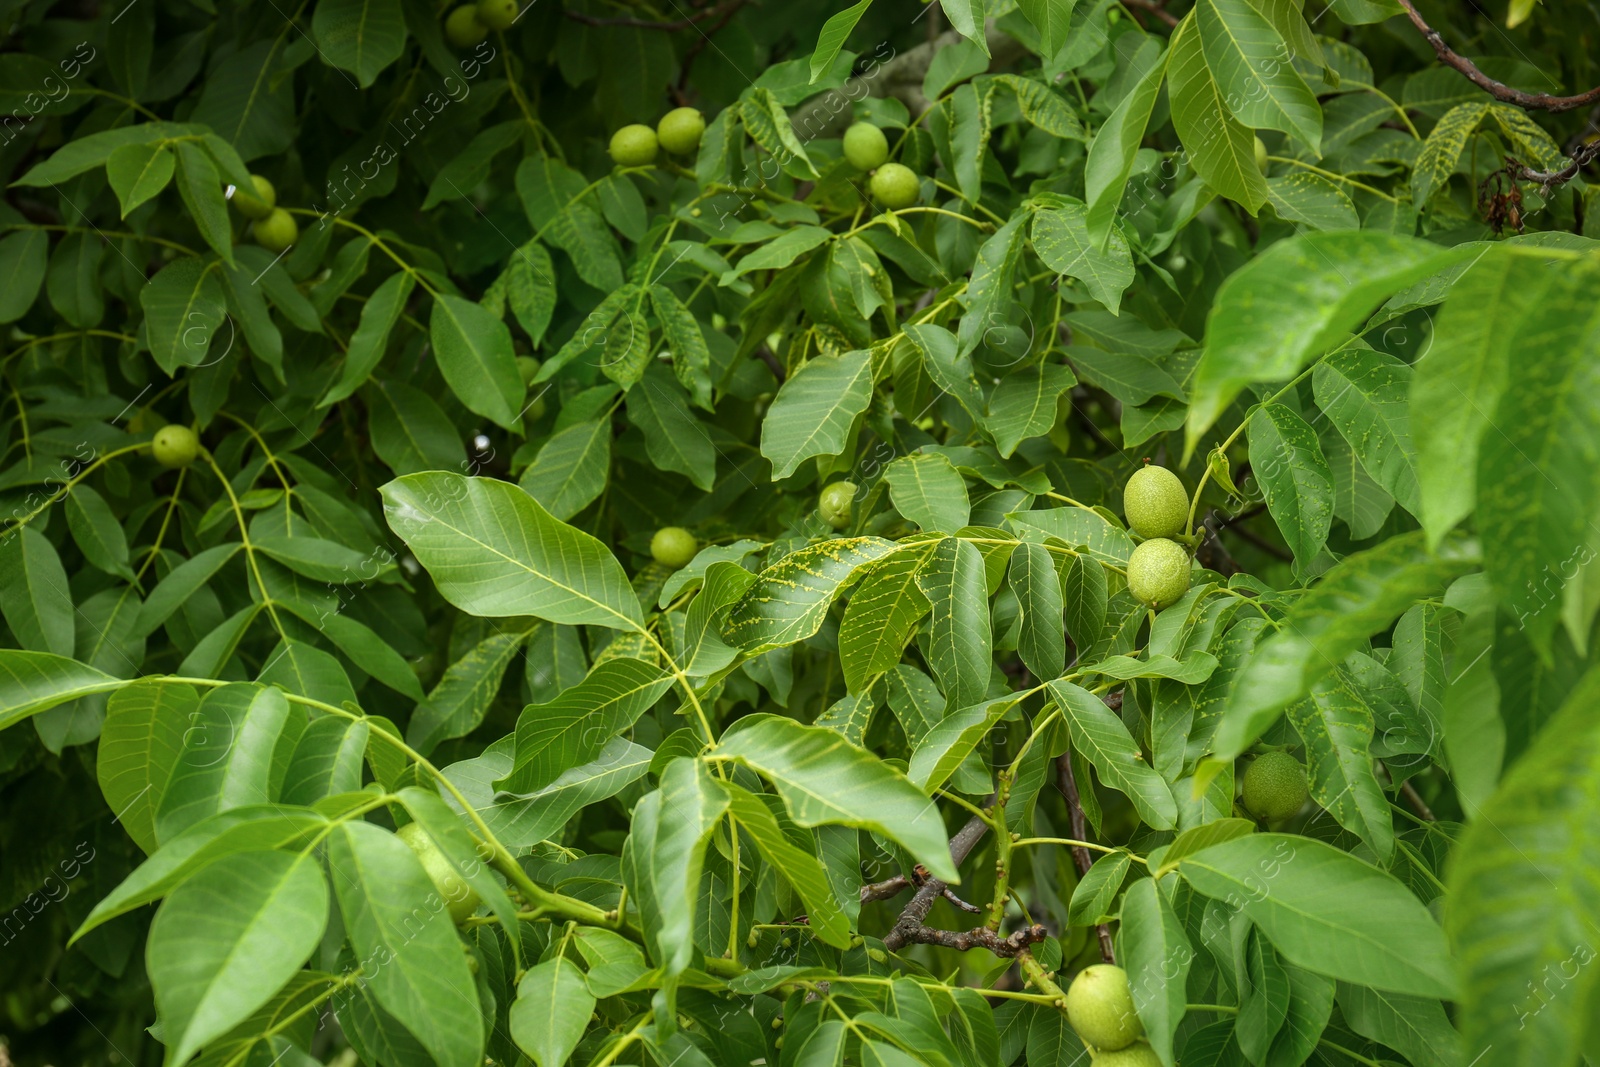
[1288,672,1395,864]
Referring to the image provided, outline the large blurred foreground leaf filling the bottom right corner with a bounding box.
[1452,670,1600,1065]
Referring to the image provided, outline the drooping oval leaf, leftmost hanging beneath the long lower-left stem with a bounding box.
[94,678,200,853]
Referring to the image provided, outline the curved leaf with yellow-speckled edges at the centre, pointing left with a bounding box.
[722,537,899,656]
